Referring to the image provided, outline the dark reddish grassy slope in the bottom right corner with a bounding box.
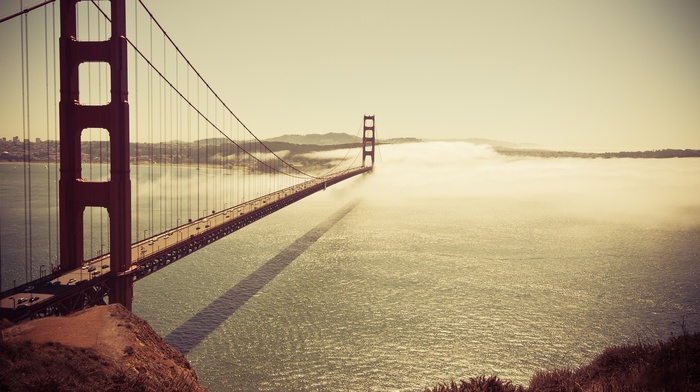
[425,330,700,392]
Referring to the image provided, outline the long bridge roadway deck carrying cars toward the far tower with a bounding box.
[0,166,372,321]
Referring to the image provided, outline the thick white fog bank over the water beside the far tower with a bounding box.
[344,142,700,225]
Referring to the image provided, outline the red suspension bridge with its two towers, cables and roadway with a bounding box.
[0,0,375,321]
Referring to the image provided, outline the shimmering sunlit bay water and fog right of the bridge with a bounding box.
[134,143,700,391]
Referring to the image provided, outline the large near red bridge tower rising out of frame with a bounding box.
[59,0,133,309]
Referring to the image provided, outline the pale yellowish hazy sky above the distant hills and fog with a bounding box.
[0,0,700,151]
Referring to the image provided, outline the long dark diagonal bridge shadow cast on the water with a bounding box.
[165,201,358,355]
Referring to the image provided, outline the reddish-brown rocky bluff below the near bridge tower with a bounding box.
[0,304,206,392]
